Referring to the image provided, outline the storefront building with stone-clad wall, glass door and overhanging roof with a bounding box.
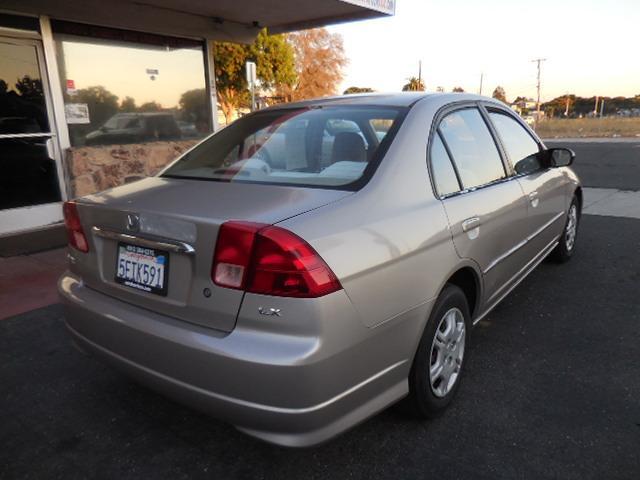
[0,0,395,251]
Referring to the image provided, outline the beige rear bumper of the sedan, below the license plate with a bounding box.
[59,272,426,447]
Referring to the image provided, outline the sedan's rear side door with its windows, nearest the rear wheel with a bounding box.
[429,106,527,302]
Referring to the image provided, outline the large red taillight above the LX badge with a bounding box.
[211,222,342,298]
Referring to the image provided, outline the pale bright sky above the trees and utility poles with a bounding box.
[329,0,640,101]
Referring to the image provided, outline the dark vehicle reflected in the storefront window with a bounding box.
[85,112,182,145]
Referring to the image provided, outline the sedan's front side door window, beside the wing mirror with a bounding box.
[489,112,542,175]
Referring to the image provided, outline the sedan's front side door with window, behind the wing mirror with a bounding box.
[487,107,567,258]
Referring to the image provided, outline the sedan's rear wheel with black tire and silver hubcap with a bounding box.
[408,285,471,418]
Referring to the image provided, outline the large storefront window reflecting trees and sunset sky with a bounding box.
[53,22,211,146]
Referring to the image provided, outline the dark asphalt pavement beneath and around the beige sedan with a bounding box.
[0,216,640,480]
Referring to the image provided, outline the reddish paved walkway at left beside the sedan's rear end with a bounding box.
[0,248,67,320]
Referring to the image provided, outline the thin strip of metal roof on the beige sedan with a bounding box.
[262,92,504,111]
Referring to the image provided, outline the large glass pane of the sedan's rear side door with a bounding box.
[439,108,506,189]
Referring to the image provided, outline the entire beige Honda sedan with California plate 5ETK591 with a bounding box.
[59,93,582,446]
